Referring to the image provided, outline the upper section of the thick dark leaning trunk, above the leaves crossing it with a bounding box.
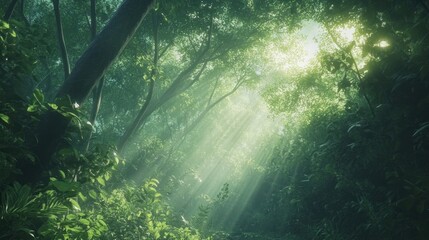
[57,0,154,104]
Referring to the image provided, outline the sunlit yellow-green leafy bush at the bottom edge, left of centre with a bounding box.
[90,179,201,239]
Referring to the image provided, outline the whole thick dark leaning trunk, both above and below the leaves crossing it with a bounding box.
[21,0,154,183]
